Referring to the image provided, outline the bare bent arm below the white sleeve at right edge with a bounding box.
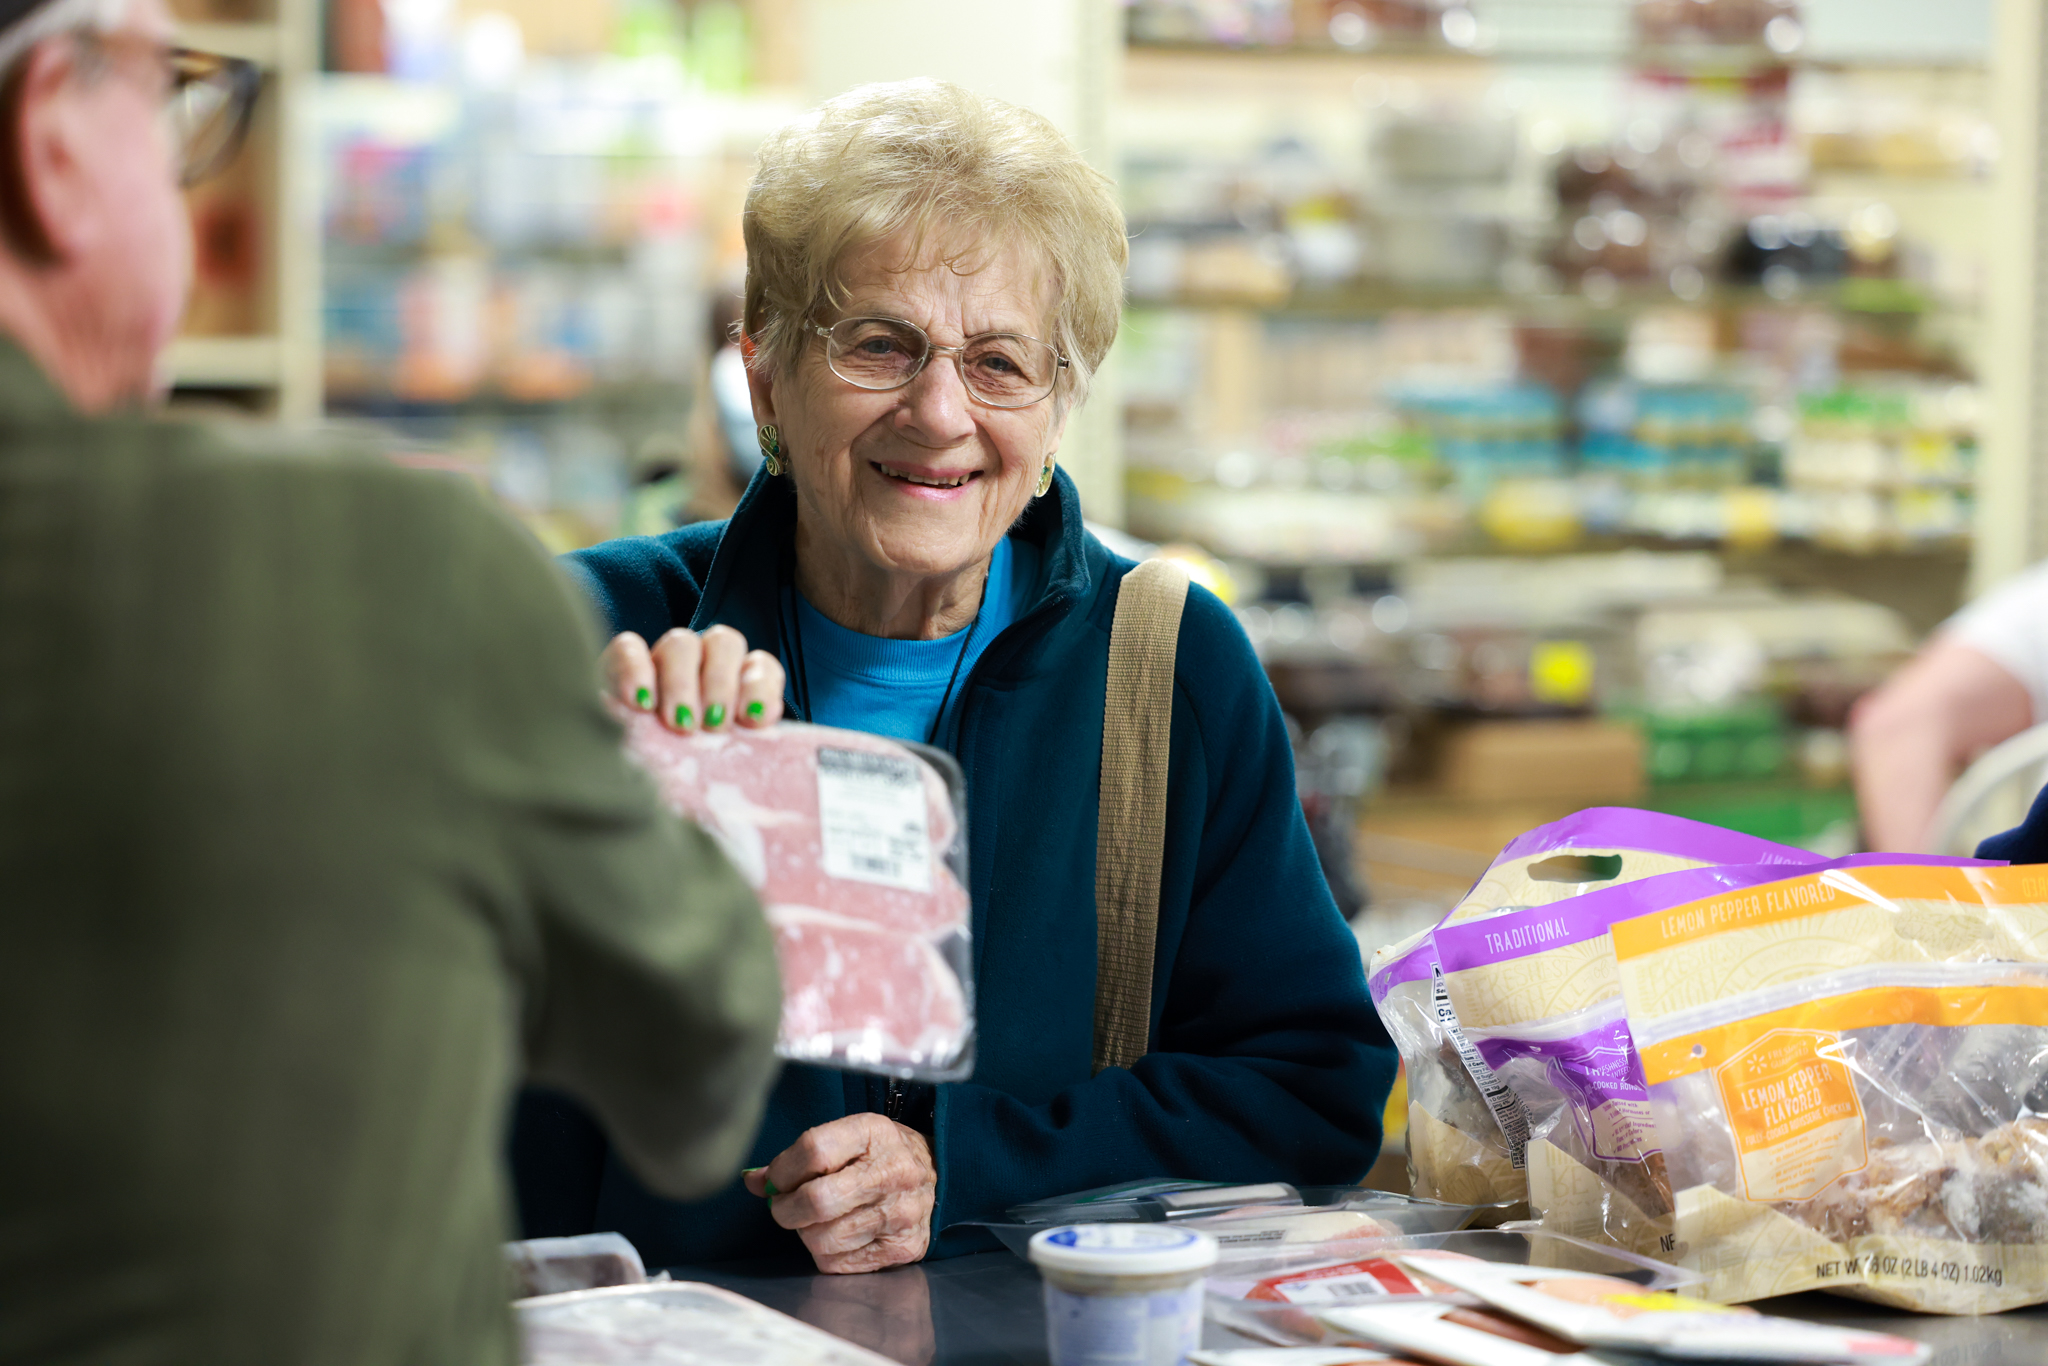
[1849,633,2034,852]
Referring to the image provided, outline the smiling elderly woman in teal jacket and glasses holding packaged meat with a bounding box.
[514,82,1395,1272]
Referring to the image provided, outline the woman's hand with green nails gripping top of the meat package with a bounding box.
[600,627,782,733]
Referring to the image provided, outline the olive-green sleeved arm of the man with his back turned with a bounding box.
[456,489,782,1198]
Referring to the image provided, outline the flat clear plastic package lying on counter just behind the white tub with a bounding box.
[979,1180,1473,1257]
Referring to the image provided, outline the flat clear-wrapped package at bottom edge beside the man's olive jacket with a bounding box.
[512,1280,893,1366]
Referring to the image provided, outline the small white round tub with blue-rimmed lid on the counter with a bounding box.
[1030,1223,1217,1366]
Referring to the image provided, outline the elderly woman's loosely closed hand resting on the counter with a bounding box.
[741,1114,938,1272]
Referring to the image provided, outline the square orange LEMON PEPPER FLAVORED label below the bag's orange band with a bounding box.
[1714,1030,1870,1202]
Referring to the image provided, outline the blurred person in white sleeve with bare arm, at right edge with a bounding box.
[1849,565,2048,858]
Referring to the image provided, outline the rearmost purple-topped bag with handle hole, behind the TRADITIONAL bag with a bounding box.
[1368,807,1812,1219]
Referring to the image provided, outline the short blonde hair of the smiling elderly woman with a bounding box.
[743,80,1130,403]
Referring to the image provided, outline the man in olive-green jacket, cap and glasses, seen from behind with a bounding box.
[0,0,778,1366]
